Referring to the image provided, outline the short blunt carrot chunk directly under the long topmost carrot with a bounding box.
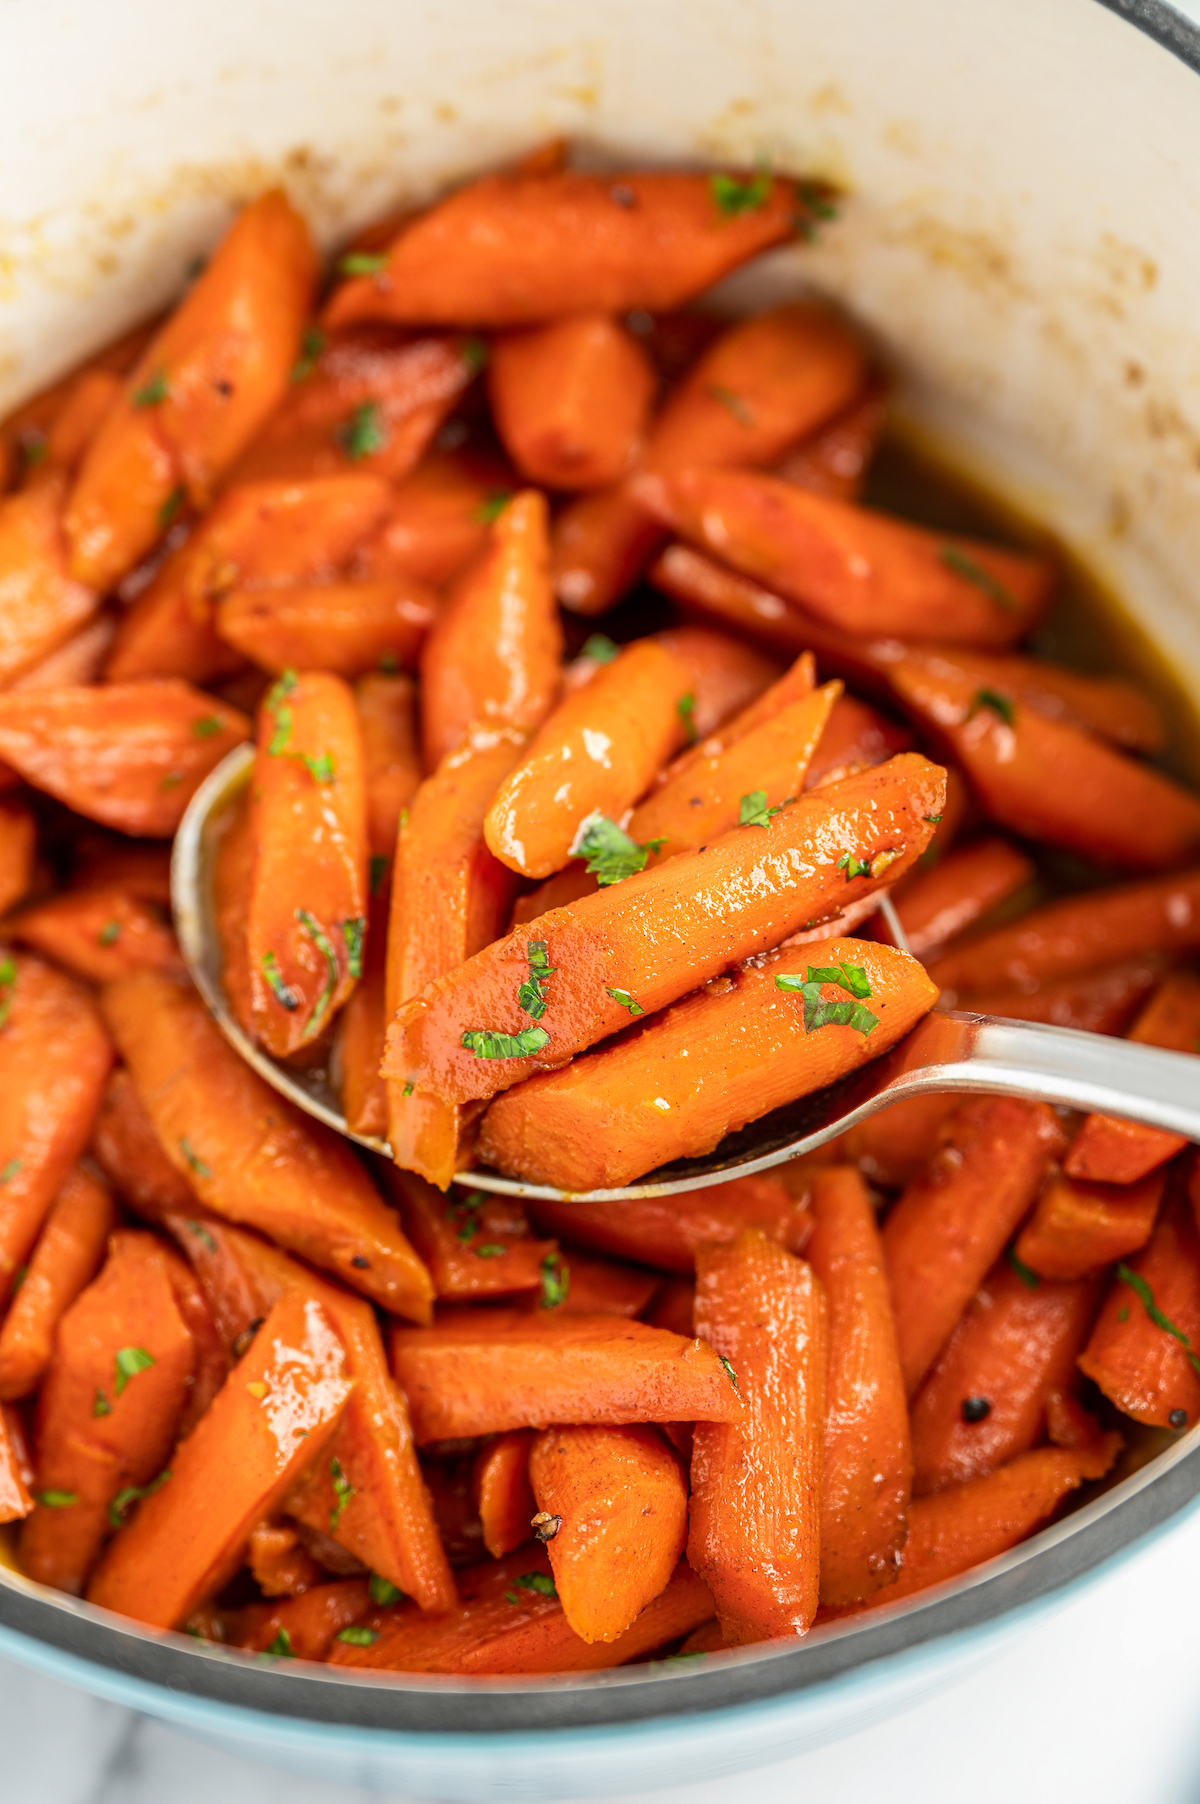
[487,314,655,489]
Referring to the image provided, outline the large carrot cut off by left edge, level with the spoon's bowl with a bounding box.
[0,951,112,1299]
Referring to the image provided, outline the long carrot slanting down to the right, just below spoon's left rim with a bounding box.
[103,972,433,1321]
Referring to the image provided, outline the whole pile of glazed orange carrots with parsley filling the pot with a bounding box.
[0,146,1200,1674]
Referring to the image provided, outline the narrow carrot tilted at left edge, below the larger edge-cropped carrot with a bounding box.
[0,1165,117,1400]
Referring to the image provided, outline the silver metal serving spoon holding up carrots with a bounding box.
[171,745,1200,1203]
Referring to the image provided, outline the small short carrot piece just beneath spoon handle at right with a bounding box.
[1014,1171,1166,1277]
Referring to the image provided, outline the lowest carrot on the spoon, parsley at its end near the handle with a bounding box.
[478,940,937,1191]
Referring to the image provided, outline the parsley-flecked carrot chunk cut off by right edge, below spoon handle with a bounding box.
[1079,1198,1200,1429]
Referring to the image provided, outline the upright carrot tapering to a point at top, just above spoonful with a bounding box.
[420,489,563,770]
